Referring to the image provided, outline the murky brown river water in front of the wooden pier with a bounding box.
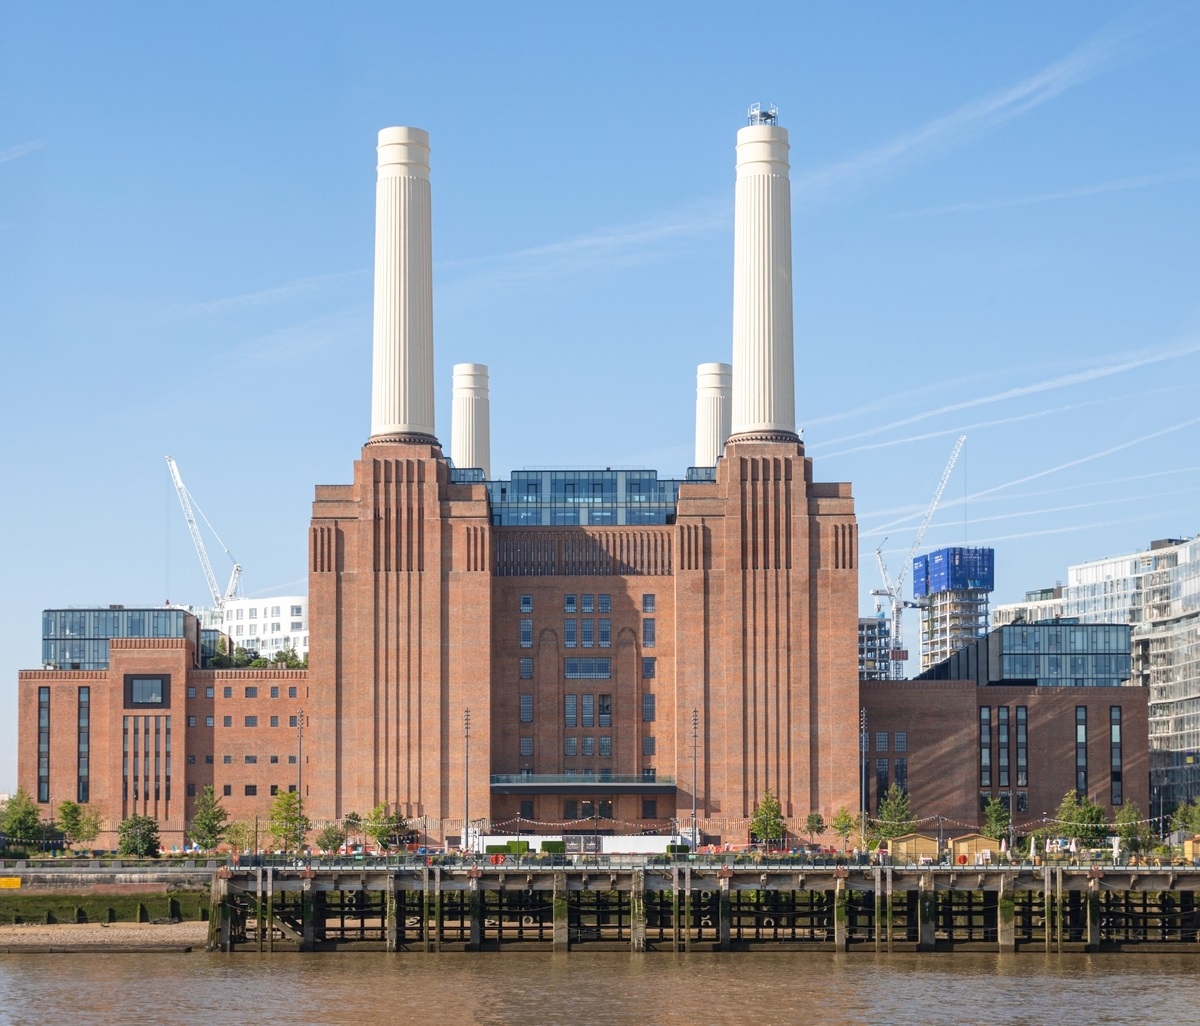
[0,952,1200,1026]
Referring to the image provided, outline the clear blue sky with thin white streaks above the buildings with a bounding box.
[0,0,1200,791]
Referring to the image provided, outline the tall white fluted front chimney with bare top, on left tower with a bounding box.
[371,127,437,444]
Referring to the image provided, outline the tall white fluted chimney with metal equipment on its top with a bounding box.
[731,118,798,442]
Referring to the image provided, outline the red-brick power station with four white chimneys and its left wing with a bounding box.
[18,108,860,848]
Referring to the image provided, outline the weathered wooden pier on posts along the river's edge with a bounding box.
[209,857,1200,954]
